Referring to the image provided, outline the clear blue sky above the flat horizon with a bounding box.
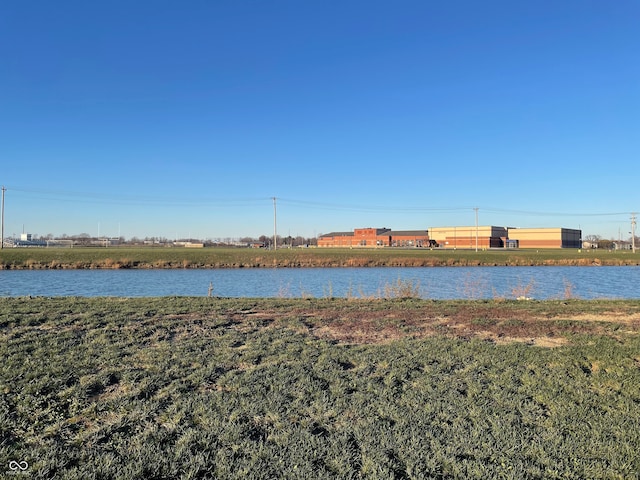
[0,0,640,238]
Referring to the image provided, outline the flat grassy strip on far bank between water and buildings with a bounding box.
[0,247,640,270]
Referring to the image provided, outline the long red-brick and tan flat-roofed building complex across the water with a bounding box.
[318,225,582,249]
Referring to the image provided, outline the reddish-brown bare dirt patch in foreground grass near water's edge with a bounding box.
[248,302,640,347]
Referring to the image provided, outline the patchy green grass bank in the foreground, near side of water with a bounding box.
[0,297,640,479]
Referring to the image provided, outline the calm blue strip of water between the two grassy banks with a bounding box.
[0,267,640,299]
